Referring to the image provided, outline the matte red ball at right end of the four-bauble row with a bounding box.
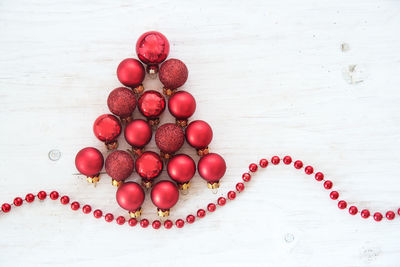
[185,120,213,149]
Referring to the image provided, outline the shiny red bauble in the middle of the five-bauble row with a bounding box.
[135,151,163,188]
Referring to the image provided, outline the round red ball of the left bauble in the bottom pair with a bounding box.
[116,182,144,212]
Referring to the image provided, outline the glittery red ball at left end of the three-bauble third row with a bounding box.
[107,87,136,118]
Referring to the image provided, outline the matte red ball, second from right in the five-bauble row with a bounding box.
[167,154,196,184]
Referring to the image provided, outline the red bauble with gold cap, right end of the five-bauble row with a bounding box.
[197,153,226,189]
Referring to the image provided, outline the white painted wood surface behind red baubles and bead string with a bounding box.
[0,0,400,266]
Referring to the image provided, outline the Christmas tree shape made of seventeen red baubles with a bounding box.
[75,31,226,218]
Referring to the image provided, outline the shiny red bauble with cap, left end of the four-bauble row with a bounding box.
[93,114,122,150]
